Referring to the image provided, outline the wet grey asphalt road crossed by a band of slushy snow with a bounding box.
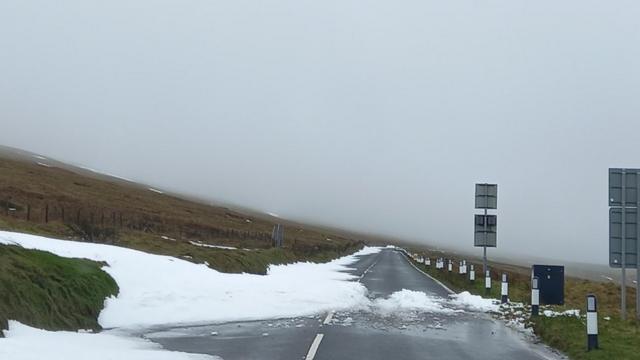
[145,250,556,360]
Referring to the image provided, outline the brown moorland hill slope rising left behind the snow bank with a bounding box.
[0,147,362,273]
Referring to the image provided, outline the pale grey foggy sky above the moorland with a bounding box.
[0,0,640,264]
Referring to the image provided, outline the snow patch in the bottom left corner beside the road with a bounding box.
[0,321,220,360]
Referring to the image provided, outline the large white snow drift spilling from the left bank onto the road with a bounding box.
[0,231,380,328]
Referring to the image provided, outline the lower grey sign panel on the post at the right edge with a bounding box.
[609,208,638,268]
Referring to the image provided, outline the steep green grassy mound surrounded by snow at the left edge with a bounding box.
[0,245,118,330]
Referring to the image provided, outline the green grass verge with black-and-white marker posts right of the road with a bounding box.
[404,255,640,360]
